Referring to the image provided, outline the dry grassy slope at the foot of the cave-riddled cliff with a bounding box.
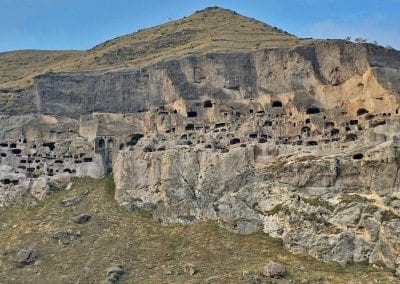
[0,178,393,283]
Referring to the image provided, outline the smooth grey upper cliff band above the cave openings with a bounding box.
[3,41,400,117]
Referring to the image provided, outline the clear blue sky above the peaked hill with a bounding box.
[0,0,400,52]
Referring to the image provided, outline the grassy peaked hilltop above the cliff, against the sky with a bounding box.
[0,8,300,89]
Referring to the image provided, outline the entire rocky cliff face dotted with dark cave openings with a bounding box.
[0,6,400,268]
